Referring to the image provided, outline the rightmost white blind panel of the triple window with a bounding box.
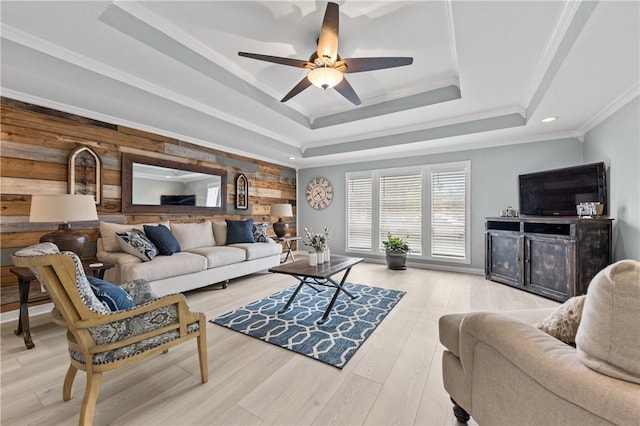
[431,170,467,259]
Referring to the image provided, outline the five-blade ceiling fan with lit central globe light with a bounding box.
[238,2,413,105]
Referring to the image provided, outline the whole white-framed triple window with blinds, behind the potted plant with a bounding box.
[346,161,470,263]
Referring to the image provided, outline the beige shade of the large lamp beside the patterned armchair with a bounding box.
[29,194,98,223]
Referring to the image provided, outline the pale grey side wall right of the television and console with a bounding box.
[584,97,640,260]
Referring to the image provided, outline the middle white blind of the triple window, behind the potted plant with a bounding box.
[378,173,422,255]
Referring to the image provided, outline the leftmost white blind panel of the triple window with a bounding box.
[347,178,373,250]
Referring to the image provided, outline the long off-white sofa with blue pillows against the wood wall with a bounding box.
[96,221,282,296]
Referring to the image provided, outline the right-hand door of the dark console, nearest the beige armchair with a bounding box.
[524,235,576,301]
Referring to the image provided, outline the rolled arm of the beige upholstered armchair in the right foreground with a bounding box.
[459,313,640,424]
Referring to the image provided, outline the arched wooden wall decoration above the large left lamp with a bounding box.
[68,146,102,205]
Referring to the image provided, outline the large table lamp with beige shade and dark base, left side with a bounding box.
[29,194,98,258]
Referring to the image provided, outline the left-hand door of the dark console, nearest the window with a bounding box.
[485,231,523,287]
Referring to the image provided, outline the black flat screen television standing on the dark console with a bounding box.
[518,163,607,216]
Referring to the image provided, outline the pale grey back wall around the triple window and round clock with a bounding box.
[298,138,583,272]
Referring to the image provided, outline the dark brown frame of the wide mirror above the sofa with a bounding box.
[121,153,227,215]
